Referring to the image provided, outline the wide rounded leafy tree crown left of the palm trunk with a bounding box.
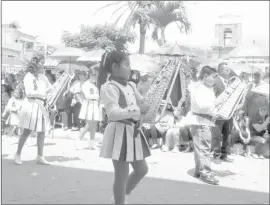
[62,25,135,51]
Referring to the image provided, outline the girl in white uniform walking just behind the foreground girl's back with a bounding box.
[77,73,102,150]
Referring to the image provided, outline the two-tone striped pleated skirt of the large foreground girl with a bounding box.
[100,122,151,162]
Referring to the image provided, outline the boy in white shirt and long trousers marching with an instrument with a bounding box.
[188,66,219,185]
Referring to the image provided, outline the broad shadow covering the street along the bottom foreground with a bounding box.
[2,159,269,204]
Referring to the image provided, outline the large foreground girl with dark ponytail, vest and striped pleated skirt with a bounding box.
[98,51,150,204]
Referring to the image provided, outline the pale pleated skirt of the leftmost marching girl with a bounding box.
[19,98,50,132]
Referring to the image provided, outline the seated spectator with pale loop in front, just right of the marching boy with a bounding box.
[230,110,251,157]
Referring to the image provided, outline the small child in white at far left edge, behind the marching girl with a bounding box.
[3,89,22,137]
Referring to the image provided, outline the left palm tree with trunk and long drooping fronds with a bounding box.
[94,1,153,54]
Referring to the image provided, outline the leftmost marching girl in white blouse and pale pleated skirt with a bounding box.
[14,55,51,165]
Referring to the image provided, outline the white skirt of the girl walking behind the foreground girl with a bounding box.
[79,100,102,121]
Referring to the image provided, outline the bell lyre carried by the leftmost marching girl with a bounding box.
[46,73,74,110]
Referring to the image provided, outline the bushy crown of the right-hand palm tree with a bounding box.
[148,1,191,46]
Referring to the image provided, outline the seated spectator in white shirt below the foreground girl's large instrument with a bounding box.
[149,104,174,149]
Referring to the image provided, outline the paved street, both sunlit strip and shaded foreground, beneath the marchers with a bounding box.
[2,130,269,204]
